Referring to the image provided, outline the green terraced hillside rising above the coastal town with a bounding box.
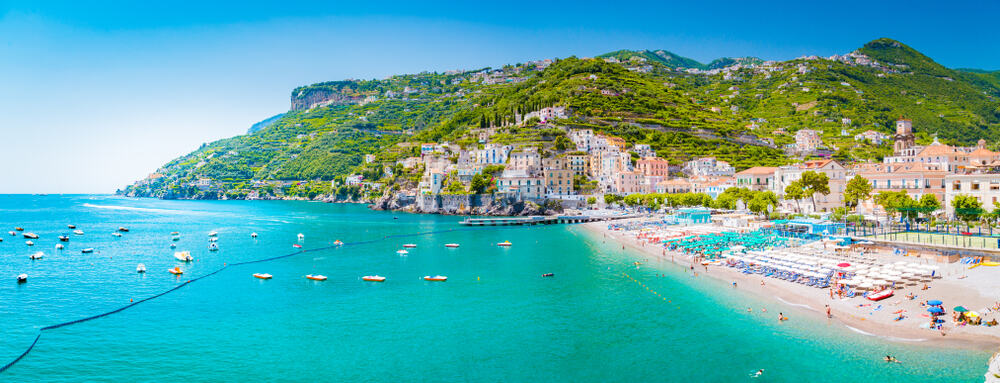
[123,39,1000,198]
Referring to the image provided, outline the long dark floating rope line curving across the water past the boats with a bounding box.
[0,226,508,373]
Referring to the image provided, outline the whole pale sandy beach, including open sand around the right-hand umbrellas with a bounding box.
[583,222,1000,351]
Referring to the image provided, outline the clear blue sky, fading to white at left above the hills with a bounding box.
[0,0,1000,194]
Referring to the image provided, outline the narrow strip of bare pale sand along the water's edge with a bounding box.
[582,222,1000,352]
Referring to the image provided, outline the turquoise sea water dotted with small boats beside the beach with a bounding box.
[0,196,989,382]
